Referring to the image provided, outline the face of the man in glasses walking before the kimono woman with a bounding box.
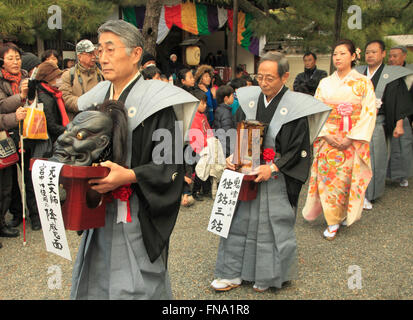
[256,61,290,99]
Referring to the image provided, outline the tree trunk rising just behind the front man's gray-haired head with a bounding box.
[142,0,163,58]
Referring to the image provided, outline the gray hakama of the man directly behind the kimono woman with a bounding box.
[366,115,389,201]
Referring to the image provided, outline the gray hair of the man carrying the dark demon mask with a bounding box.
[98,20,143,55]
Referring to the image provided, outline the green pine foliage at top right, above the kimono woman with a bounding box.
[238,0,413,52]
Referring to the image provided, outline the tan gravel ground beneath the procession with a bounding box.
[0,179,413,300]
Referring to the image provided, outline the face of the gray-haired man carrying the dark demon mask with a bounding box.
[98,32,142,83]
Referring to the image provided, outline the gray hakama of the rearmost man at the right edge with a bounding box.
[387,118,413,180]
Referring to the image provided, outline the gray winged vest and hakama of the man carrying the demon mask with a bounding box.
[70,75,198,300]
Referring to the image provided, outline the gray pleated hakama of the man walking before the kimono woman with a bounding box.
[215,173,297,288]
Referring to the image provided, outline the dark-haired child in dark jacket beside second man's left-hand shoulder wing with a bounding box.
[214,85,236,158]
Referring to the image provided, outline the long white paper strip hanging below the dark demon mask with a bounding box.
[32,160,72,261]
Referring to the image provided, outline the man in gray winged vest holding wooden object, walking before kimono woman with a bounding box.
[211,52,331,292]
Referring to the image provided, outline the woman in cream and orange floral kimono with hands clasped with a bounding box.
[303,40,376,240]
